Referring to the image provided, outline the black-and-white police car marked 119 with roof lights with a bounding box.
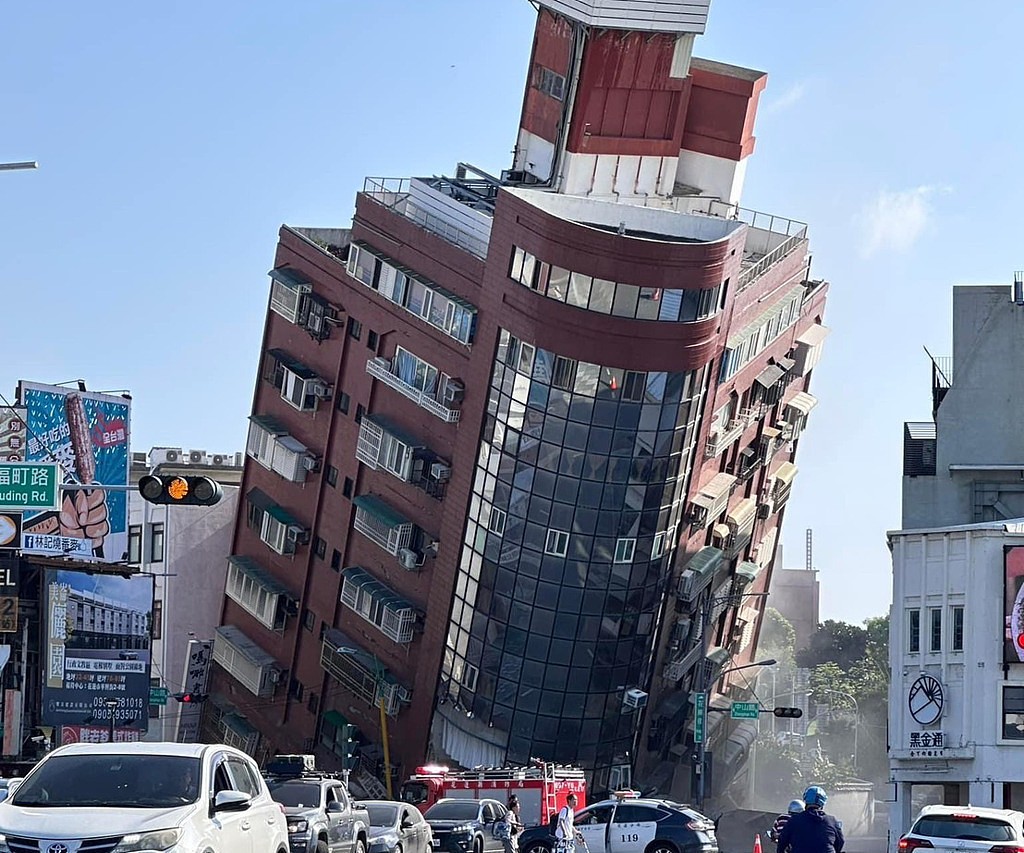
[519,792,718,853]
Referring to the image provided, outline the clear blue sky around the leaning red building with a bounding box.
[0,0,1024,621]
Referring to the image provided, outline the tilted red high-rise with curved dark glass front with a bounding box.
[213,3,827,796]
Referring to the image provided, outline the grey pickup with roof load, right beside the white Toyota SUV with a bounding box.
[267,771,370,853]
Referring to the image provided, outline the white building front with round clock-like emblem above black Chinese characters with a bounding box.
[889,520,1024,839]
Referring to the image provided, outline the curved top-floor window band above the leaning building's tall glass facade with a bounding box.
[509,247,729,323]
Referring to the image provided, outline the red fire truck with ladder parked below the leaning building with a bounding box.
[401,761,587,826]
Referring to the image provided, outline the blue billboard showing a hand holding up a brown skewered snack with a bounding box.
[18,382,131,562]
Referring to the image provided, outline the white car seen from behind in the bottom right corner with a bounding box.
[897,806,1024,853]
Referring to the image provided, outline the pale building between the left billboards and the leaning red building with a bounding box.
[128,447,242,740]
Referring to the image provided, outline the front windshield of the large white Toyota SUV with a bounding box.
[9,754,202,809]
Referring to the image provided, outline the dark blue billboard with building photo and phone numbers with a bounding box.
[42,569,153,731]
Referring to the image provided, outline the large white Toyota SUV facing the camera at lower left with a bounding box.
[0,743,288,853]
